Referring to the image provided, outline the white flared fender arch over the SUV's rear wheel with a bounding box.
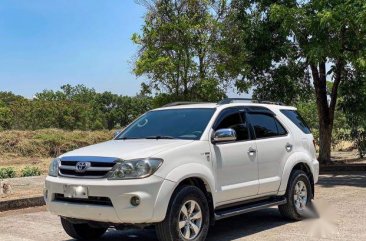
[278,152,314,195]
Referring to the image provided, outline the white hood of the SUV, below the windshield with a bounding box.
[61,139,193,160]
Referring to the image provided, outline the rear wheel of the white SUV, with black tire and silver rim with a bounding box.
[278,170,313,221]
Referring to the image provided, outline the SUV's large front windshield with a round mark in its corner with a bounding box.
[116,108,215,140]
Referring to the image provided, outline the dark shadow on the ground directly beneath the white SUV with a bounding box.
[65,208,288,241]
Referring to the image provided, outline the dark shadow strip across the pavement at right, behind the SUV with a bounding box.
[317,172,366,188]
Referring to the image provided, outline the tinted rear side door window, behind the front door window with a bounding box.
[249,114,287,138]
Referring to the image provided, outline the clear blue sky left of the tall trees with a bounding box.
[0,0,145,98]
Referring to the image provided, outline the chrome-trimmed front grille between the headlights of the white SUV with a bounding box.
[59,157,117,178]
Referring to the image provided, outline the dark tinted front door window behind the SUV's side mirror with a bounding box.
[215,109,249,141]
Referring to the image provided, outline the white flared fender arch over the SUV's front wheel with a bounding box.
[153,163,215,221]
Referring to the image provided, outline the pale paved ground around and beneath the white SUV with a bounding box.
[0,173,366,241]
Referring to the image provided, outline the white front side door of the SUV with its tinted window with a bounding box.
[211,108,259,203]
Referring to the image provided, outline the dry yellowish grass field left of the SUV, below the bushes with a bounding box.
[0,129,113,178]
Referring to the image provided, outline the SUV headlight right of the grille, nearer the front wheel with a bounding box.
[108,158,163,180]
